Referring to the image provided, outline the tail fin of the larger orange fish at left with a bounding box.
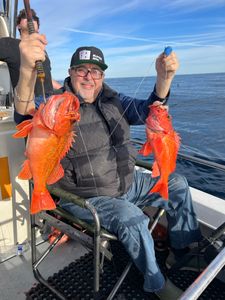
[30,189,56,214]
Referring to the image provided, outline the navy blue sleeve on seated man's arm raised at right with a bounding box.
[118,87,170,125]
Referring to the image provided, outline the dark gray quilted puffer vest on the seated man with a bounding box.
[57,78,137,198]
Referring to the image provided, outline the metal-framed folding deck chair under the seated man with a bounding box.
[30,161,164,300]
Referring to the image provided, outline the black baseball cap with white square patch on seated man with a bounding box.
[70,46,108,71]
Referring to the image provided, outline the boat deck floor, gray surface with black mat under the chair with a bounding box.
[0,240,225,300]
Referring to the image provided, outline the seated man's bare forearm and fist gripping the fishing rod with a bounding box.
[14,33,47,115]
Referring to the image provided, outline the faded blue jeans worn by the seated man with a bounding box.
[60,171,201,292]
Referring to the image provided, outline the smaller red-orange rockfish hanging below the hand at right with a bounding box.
[139,105,180,200]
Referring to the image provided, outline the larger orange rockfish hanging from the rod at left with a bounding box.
[13,92,80,214]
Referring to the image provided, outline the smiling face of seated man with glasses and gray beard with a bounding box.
[69,64,104,103]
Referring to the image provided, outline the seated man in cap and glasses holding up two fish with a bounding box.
[15,34,200,300]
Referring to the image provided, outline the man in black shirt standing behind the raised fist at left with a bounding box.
[0,9,61,96]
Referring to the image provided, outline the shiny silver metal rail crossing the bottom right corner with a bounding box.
[179,248,225,300]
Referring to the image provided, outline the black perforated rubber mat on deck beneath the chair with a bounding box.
[26,242,225,300]
